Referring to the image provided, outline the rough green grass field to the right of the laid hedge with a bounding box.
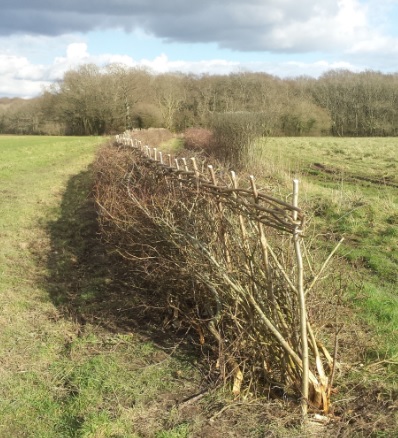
[249,138,398,437]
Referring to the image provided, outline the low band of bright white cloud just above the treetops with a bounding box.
[0,43,366,97]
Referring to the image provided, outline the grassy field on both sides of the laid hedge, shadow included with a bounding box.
[0,136,398,438]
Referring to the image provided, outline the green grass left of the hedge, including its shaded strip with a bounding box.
[0,136,199,438]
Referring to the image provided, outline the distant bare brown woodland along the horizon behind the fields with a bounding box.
[0,64,398,136]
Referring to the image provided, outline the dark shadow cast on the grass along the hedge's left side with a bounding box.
[45,169,197,347]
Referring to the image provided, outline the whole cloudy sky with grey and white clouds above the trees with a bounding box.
[0,0,398,98]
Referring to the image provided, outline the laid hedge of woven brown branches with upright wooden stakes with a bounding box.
[96,133,335,414]
